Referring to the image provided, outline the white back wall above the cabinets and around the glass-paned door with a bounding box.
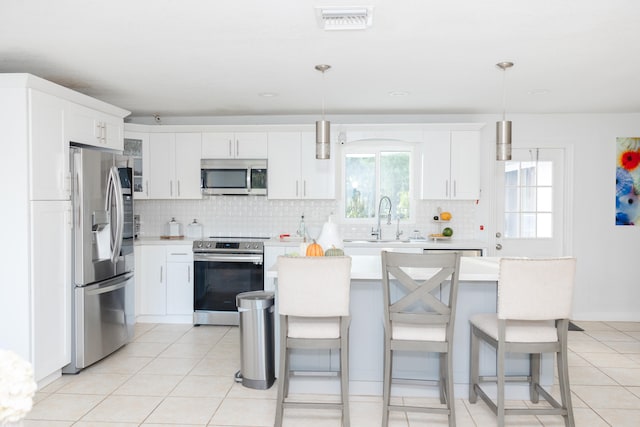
[131,113,640,321]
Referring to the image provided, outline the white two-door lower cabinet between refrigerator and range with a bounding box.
[136,245,193,323]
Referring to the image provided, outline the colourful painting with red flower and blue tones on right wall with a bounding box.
[616,138,640,225]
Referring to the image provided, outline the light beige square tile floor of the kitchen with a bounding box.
[24,322,640,427]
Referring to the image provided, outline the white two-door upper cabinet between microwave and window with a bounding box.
[267,132,336,199]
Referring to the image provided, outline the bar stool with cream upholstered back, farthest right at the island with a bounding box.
[469,258,576,427]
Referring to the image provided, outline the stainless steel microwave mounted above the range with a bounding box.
[200,159,267,196]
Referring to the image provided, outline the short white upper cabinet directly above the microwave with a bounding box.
[202,132,267,159]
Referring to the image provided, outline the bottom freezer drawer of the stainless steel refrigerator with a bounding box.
[75,274,135,369]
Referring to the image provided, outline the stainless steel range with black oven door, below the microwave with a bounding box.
[193,237,264,325]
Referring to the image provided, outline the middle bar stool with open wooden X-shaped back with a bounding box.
[382,251,460,427]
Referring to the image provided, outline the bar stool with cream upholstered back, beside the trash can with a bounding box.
[275,256,351,427]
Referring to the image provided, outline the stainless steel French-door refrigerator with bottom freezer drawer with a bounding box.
[63,146,135,373]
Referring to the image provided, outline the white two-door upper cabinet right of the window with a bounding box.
[420,131,480,200]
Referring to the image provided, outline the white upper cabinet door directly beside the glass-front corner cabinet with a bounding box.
[149,133,176,199]
